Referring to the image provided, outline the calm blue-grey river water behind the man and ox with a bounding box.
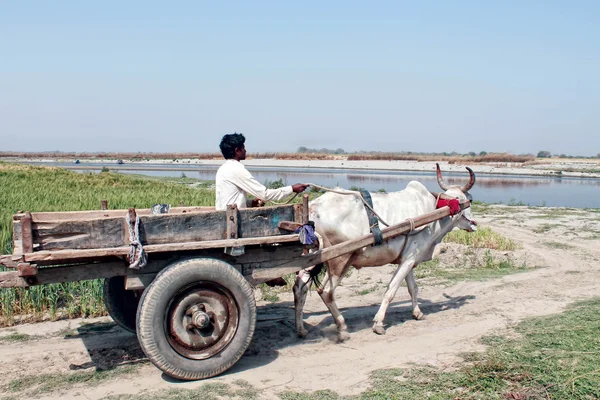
[16,163,600,208]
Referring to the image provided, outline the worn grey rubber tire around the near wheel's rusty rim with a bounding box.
[137,258,256,380]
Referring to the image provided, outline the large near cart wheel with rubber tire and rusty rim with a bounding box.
[137,258,256,380]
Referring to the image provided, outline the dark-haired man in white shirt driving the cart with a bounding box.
[215,133,308,210]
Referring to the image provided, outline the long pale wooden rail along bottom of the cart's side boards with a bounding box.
[24,235,298,262]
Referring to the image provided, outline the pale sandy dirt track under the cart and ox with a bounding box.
[0,206,600,399]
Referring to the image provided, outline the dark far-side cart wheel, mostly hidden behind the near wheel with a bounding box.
[104,276,140,333]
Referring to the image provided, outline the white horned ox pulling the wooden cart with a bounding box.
[294,165,477,341]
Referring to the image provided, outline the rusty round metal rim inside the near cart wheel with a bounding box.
[165,282,239,360]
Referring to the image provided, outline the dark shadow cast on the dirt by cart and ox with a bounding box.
[65,296,475,383]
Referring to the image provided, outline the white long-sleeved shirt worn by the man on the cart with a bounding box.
[215,160,293,210]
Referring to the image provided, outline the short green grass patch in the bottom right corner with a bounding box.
[281,299,600,400]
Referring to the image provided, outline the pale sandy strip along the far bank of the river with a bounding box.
[3,158,600,178]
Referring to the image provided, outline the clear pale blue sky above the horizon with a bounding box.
[0,0,600,155]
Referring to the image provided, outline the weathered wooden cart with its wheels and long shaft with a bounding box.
[0,195,470,380]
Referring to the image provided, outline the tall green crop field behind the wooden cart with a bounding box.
[0,163,214,325]
